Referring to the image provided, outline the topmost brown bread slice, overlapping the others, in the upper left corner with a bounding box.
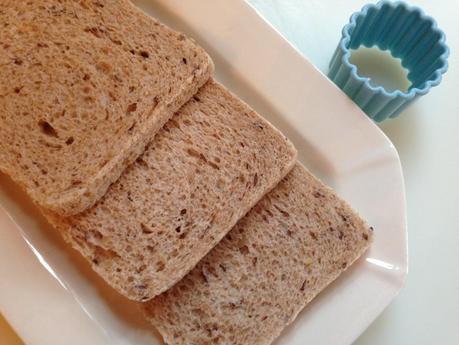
[0,0,213,215]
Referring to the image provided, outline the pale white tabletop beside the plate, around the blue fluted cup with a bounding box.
[249,0,459,345]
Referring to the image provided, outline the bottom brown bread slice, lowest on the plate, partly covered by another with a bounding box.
[145,164,372,345]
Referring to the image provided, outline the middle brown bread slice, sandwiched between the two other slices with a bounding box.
[48,80,296,301]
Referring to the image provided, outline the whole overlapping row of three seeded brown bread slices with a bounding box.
[0,0,372,345]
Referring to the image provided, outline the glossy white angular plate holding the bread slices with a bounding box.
[0,0,407,345]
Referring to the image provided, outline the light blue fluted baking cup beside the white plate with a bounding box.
[328,0,449,122]
